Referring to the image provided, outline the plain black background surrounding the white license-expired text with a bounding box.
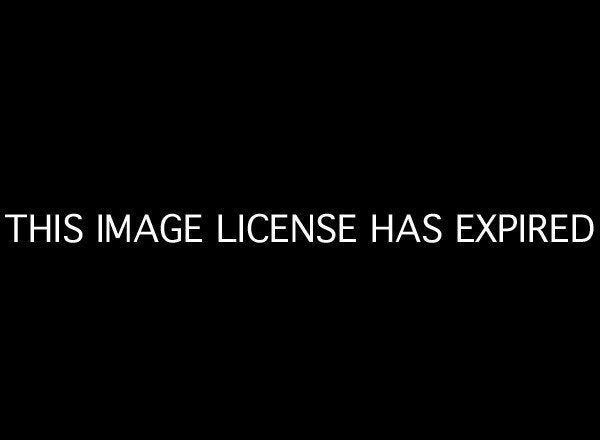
[1,5,598,433]
